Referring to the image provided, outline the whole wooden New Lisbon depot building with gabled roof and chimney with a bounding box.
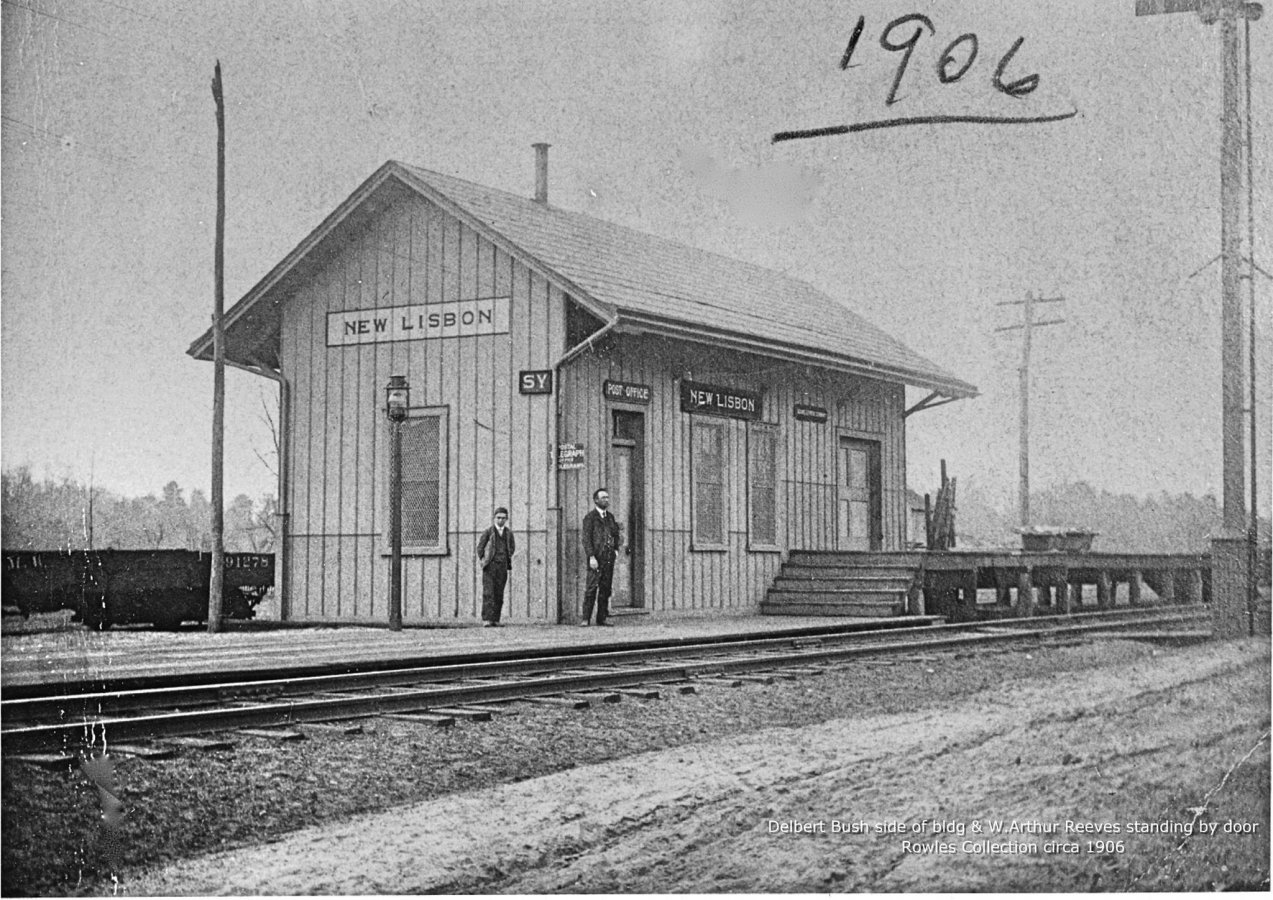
[190,151,976,624]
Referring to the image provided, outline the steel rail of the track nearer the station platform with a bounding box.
[0,607,1206,735]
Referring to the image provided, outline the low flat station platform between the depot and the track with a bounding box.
[0,615,939,690]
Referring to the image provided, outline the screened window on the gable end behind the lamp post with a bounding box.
[402,410,447,551]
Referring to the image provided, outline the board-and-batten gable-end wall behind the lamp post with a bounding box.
[281,196,564,622]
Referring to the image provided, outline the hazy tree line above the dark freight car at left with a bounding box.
[0,466,278,552]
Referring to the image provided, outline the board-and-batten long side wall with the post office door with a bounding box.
[559,335,906,621]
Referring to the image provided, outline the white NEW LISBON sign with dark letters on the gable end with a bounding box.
[327,297,509,346]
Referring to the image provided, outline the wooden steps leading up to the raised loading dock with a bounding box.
[760,550,923,617]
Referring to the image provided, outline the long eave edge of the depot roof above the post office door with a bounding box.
[616,311,980,400]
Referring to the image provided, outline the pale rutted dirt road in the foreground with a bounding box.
[121,640,1269,895]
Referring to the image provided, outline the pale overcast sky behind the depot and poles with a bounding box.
[0,0,1273,512]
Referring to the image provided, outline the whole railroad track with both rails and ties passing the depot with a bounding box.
[0,606,1209,757]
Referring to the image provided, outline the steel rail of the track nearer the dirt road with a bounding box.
[0,614,1195,752]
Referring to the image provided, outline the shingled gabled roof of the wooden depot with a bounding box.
[190,162,976,397]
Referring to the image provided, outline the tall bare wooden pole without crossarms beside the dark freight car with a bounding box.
[207,60,225,634]
